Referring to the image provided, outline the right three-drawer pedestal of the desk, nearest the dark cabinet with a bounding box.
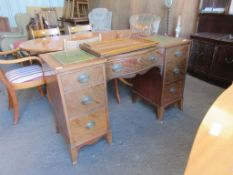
[132,36,190,120]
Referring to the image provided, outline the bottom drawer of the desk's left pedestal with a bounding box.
[70,109,108,144]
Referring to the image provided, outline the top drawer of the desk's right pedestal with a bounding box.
[166,45,189,62]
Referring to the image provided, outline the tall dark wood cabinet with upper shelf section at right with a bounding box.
[189,1,233,86]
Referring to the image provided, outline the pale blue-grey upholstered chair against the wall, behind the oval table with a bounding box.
[88,8,112,31]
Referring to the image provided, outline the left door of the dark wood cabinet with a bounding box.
[189,40,214,75]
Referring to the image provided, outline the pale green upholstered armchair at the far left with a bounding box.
[0,13,31,51]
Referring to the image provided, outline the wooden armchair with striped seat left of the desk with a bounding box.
[0,49,45,124]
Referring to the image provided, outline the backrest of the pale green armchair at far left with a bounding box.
[15,13,31,36]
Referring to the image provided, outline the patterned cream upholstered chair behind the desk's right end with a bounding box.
[129,13,161,35]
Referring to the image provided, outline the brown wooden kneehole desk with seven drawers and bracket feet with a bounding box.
[40,30,189,164]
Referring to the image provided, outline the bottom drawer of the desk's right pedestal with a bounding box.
[164,81,184,104]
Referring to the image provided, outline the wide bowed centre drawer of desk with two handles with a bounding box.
[106,49,164,79]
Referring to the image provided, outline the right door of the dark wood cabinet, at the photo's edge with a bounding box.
[210,44,233,81]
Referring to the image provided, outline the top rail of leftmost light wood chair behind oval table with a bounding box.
[30,27,61,39]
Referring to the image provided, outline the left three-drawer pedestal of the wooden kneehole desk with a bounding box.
[40,52,112,164]
